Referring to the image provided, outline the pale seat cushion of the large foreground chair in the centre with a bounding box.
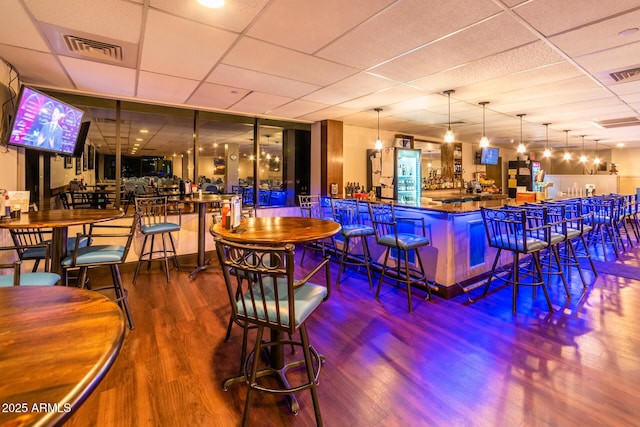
[236,278,327,326]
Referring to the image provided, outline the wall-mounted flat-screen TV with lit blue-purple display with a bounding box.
[7,85,83,156]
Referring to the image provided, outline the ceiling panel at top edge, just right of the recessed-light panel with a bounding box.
[247,0,393,54]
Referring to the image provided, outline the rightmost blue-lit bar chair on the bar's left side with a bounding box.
[369,203,432,313]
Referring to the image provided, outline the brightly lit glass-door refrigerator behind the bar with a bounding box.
[394,148,422,206]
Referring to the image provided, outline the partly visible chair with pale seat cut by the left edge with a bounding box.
[0,242,61,287]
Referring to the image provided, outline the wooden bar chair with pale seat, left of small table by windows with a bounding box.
[133,196,182,284]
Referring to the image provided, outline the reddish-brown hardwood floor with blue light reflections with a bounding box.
[67,242,640,427]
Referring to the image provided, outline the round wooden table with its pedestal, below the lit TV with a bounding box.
[0,209,124,275]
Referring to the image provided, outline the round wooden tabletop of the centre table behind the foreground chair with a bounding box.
[210,216,341,245]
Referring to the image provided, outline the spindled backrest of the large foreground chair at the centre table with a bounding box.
[216,238,297,333]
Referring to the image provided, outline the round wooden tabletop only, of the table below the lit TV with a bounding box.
[0,209,124,228]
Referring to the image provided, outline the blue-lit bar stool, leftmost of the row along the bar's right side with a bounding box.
[480,207,553,314]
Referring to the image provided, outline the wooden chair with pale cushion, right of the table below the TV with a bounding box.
[62,212,140,329]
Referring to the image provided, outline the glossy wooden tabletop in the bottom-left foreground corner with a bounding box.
[0,286,125,426]
